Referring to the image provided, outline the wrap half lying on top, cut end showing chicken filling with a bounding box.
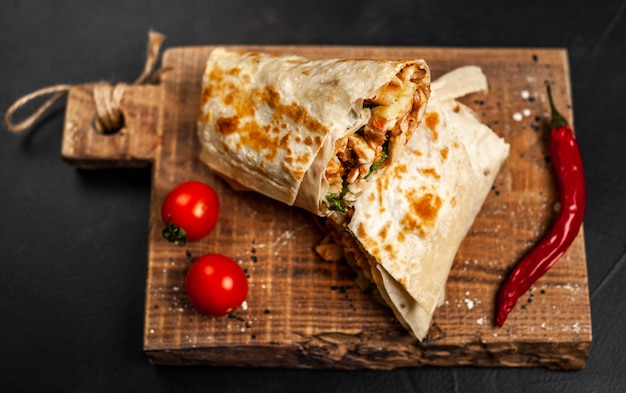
[198,48,430,216]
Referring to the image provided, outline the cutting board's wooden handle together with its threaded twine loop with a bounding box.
[4,31,171,168]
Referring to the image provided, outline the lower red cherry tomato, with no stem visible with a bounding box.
[185,254,248,316]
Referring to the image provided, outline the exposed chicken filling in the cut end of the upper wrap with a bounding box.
[325,66,427,212]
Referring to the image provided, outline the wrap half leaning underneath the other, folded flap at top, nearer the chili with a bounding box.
[320,66,509,340]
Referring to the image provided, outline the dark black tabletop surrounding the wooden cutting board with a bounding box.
[0,0,626,392]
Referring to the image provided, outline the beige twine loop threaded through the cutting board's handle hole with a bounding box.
[4,31,167,133]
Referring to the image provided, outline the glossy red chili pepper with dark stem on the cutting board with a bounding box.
[496,81,587,326]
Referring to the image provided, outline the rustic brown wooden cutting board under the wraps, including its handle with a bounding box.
[62,46,591,369]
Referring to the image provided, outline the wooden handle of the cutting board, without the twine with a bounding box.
[61,83,164,169]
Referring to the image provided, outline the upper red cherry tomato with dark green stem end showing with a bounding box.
[161,181,220,245]
